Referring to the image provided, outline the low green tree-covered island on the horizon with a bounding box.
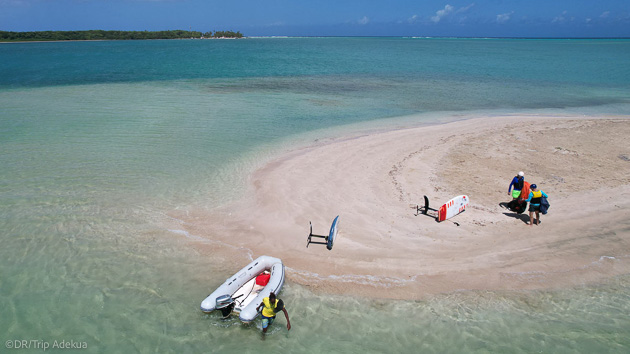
[0,30,243,42]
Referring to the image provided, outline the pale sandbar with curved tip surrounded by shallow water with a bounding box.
[173,116,630,299]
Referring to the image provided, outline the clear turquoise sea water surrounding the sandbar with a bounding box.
[0,38,630,353]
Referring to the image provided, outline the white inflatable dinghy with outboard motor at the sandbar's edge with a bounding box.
[201,256,284,323]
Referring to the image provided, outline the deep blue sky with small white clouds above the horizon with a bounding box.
[0,0,630,37]
